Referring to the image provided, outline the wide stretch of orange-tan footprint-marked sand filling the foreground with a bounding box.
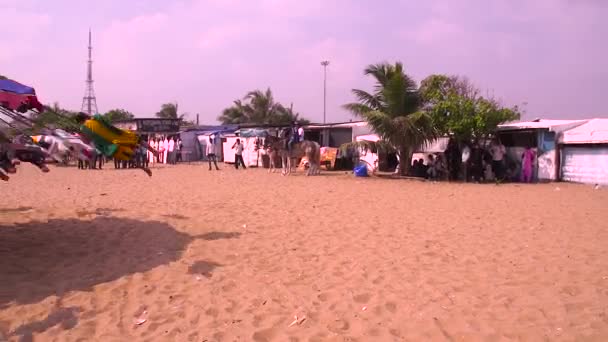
[0,164,608,342]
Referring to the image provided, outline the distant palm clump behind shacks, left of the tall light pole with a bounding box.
[218,88,309,125]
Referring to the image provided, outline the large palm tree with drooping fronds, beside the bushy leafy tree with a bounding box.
[343,62,436,176]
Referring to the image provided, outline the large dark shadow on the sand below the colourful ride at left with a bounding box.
[0,216,240,309]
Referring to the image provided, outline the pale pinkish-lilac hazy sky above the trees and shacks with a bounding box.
[0,0,608,123]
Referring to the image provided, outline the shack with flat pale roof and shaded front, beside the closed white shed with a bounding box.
[496,119,587,181]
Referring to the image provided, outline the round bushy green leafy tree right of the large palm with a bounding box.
[420,75,520,144]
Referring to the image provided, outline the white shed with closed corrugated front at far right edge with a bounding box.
[558,119,608,185]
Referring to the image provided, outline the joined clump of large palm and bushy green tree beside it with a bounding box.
[343,62,520,175]
